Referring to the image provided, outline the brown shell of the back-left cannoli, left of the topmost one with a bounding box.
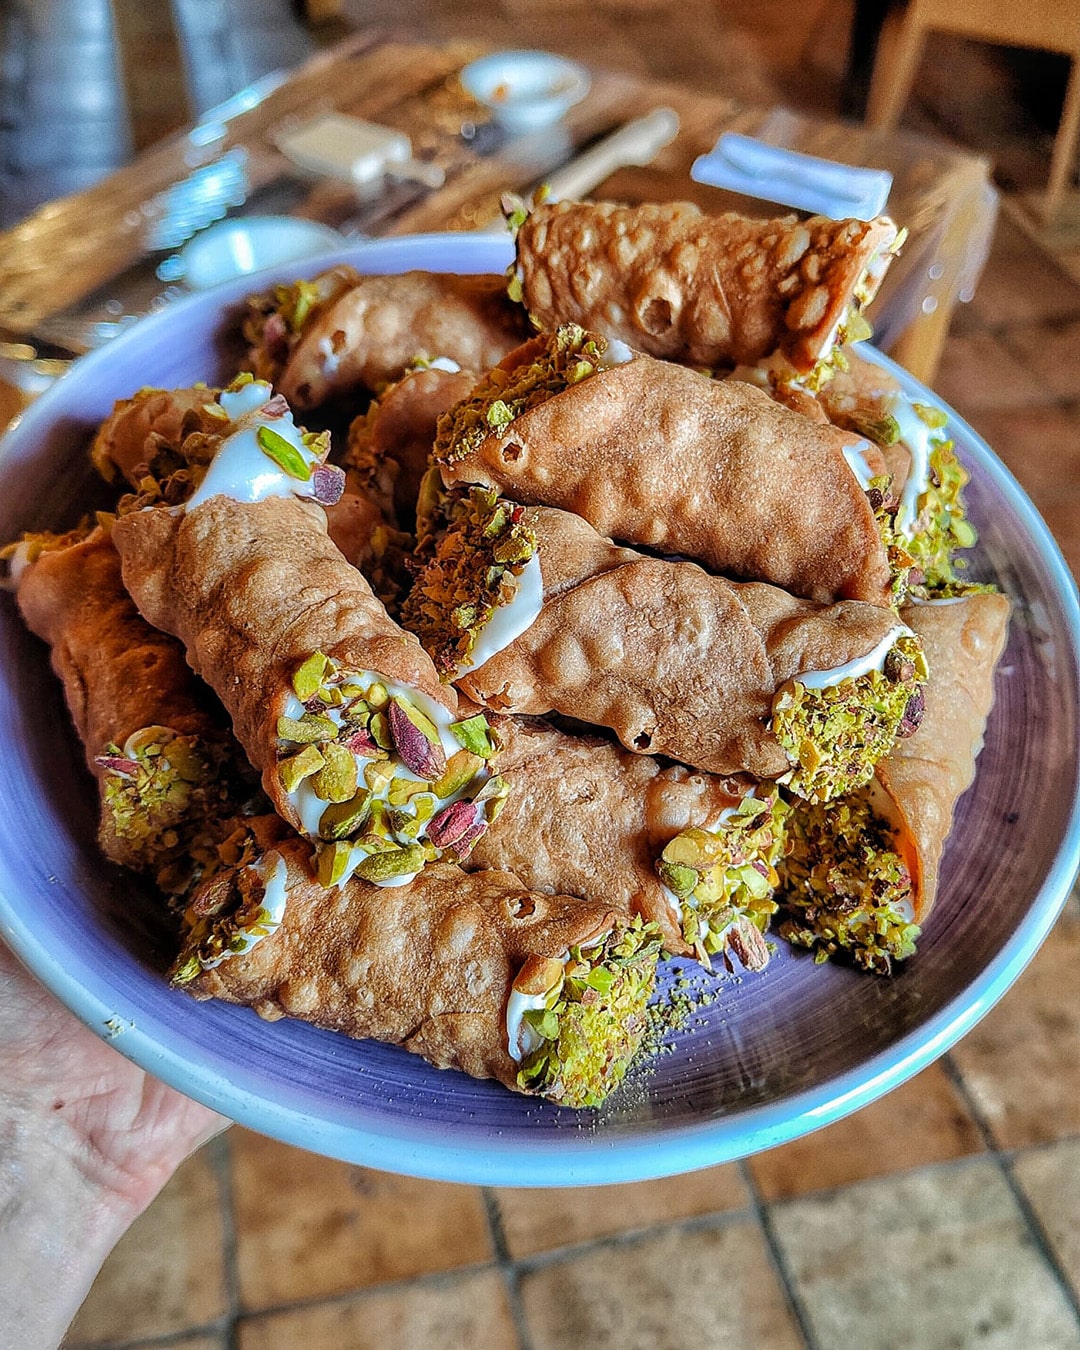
[278,271,528,410]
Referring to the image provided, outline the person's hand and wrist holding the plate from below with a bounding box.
[0,941,228,1350]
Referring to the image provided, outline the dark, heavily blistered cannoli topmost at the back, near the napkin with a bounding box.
[512,201,899,373]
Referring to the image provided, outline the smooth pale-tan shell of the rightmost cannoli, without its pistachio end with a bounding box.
[876,593,1010,923]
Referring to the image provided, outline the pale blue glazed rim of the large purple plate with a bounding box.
[0,234,1080,1187]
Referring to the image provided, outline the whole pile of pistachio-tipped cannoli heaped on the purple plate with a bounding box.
[8,204,1008,1107]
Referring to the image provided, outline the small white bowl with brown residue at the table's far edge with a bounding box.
[462,51,590,131]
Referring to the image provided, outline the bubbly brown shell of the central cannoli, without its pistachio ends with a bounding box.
[458,508,896,778]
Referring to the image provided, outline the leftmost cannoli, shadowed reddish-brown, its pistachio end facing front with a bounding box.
[8,528,243,888]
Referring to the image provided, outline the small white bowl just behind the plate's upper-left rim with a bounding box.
[180,216,342,290]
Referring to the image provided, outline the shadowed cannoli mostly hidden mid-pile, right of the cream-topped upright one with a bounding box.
[344,362,478,525]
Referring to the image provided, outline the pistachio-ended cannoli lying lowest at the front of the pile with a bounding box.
[174,838,659,1107]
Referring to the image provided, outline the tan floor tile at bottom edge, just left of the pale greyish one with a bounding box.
[518,1220,803,1350]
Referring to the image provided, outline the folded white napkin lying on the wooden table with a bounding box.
[690,131,892,220]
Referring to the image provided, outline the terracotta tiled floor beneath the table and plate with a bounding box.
[14,0,1080,1350]
